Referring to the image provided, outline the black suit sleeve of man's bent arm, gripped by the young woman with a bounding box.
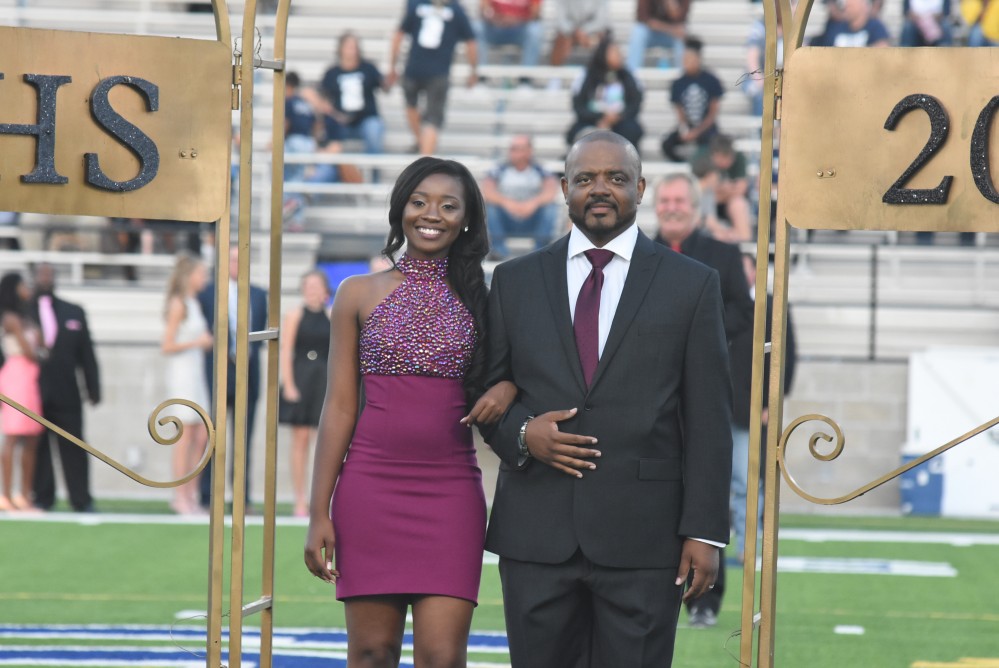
[479,267,531,468]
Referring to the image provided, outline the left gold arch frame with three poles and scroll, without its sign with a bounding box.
[0,0,291,668]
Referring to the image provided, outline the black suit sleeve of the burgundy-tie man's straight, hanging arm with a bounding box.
[679,272,732,543]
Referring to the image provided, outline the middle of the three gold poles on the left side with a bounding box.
[229,0,257,668]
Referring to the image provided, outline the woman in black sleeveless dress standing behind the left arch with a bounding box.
[278,269,332,517]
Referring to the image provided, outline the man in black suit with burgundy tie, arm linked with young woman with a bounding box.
[485,131,732,668]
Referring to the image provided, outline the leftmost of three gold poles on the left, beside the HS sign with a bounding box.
[205,0,232,668]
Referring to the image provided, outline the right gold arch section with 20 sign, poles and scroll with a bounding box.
[739,0,999,668]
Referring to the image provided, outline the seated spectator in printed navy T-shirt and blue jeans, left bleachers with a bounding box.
[319,31,386,154]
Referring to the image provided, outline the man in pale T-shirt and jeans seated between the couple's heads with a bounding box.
[482,135,558,259]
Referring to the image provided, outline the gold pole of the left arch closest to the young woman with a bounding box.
[260,0,291,668]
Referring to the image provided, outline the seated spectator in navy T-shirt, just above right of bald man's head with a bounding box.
[662,37,722,162]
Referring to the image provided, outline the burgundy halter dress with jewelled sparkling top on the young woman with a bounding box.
[331,255,486,603]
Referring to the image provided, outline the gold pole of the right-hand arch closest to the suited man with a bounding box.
[739,0,780,666]
